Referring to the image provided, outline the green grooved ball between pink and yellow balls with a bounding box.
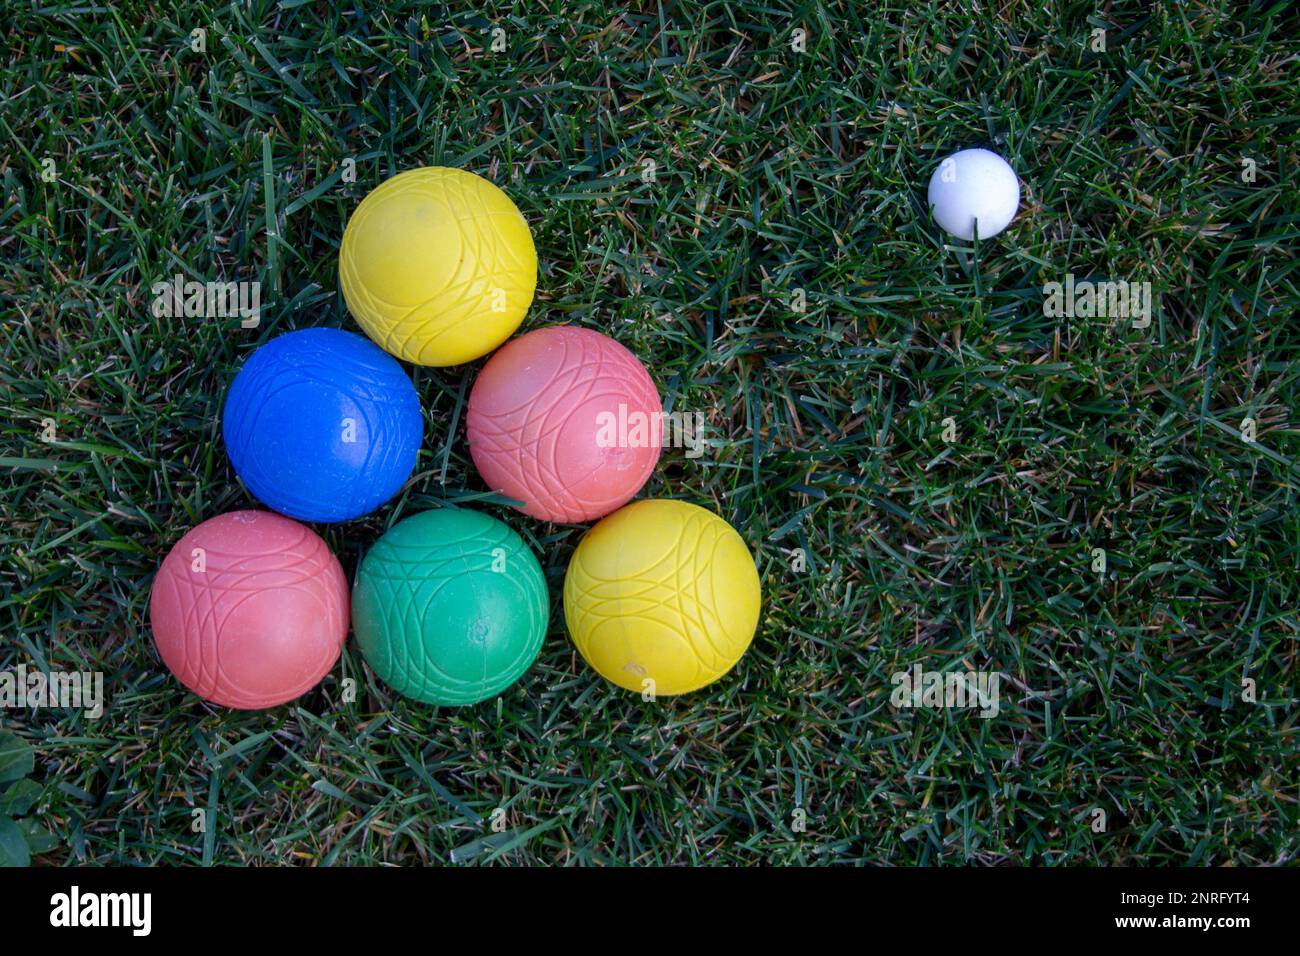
[352,509,550,705]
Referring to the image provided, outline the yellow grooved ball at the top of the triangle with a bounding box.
[338,166,537,365]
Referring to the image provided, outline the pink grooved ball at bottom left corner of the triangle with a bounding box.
[150,511,348,710]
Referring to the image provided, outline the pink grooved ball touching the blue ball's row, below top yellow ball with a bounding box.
[467,325,663,522]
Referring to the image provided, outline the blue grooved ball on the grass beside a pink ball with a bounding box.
[221,329,424,522]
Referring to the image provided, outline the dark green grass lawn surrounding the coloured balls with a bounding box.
[0,0,1300,865]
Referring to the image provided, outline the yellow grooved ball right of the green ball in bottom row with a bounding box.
[564,499,762,695]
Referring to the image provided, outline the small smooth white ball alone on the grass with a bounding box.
[930,150,1021,241]
